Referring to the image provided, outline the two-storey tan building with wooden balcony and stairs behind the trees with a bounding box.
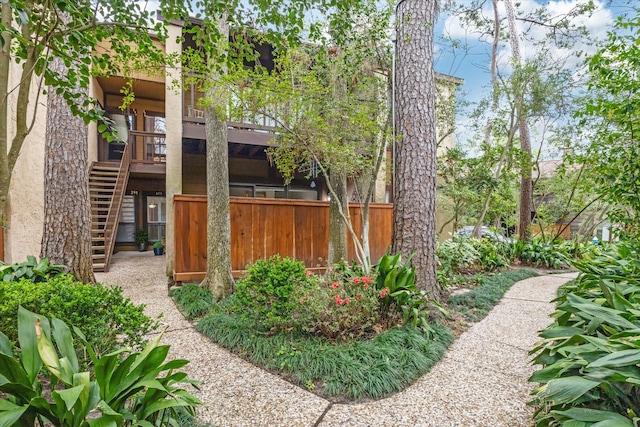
[0,17,461,273]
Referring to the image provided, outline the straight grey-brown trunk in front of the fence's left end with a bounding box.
[200,17,232,300]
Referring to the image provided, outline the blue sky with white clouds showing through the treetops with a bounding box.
[434,0,634,158]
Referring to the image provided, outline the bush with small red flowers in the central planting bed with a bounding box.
[296,269,380,340]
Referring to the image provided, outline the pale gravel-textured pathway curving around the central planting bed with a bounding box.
[96,252,575,427]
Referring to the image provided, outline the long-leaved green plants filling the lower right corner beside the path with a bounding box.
[530,243,640,427]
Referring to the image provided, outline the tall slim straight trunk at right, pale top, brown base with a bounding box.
[504,0,533,241]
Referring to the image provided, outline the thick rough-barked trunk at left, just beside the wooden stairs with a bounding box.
[40,58,96,283]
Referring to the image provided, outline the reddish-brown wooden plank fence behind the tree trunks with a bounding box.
[173,195,393,282]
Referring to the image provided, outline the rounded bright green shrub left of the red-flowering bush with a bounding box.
[234,255,308,329]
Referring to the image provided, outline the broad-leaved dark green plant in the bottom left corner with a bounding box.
[0,307,200,427]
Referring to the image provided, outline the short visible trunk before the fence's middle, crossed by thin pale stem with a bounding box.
[328,169,349,265]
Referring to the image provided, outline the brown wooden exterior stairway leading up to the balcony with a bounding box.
[89,150,130,271]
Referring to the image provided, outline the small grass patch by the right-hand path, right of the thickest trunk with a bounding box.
[448,268,538,322]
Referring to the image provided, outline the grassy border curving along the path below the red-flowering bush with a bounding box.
[196,312,453,400]
